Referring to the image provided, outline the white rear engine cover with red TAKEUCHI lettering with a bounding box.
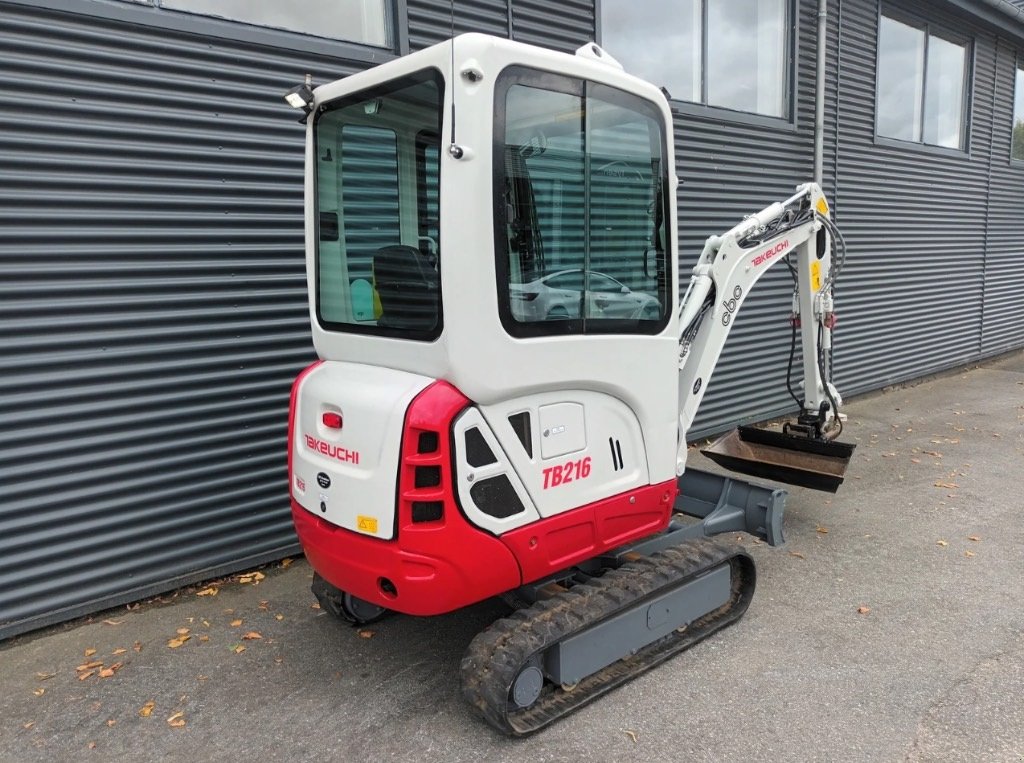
[292,362,433,539]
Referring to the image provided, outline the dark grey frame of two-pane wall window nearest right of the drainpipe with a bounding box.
[872,3,978,158]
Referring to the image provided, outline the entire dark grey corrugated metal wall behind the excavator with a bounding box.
[0,0,1024,637]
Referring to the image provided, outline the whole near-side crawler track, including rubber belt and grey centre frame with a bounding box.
[461,539,757,736]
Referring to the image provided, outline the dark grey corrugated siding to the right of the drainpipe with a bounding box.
[826,0,1024,394]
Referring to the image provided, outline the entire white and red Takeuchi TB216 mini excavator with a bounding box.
[288,34,852,734]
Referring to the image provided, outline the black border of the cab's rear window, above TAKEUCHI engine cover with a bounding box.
[311,67,447,342]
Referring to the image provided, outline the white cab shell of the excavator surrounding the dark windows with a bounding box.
[306,34,679,487]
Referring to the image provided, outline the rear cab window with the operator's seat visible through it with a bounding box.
[314,73,441,339]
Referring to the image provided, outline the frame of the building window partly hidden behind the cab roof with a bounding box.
[595,0,800,132]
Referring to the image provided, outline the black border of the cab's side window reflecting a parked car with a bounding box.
[492,65,677,339]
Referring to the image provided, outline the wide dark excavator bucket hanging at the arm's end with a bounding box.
[701,426,856,493]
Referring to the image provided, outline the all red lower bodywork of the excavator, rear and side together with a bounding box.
[289,372,677,616]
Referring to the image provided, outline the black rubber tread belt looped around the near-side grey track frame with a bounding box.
[461,539,756,736]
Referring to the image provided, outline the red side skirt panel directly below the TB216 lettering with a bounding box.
[502,479,679,583]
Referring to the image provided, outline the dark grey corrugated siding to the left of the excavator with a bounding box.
[0,3,368,637]
